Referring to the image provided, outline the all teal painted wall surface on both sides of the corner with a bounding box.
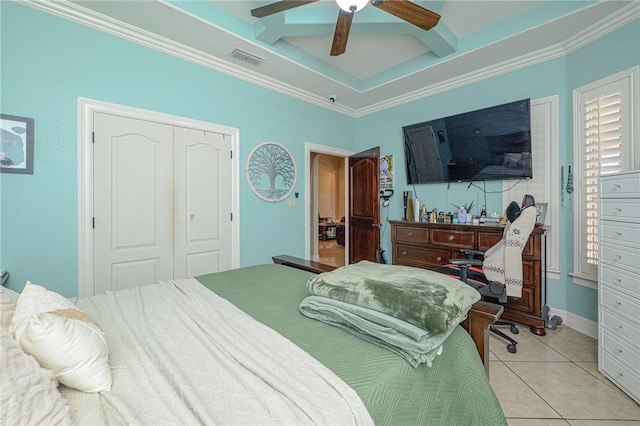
[0,2,640,321]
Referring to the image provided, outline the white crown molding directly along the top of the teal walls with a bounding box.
[13,0,640,118]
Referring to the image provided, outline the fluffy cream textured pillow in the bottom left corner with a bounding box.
[0,329,71,425]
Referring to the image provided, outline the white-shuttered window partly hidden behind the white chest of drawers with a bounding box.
[572,67,638,288]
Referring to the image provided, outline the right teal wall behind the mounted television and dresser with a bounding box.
[355,20,640,321]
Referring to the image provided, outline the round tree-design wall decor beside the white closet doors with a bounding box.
[246,142,298,203]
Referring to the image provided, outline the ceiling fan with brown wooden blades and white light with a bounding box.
[251,0,440,56]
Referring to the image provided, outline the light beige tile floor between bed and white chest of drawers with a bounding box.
[489,324,640,426]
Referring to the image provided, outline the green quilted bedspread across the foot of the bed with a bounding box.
[197,265,507,425]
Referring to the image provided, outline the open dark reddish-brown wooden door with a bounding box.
[349,147,380,263]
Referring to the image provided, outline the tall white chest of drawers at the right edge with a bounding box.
[598,171,640,403]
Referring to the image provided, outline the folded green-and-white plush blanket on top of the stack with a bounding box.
[307,261,480,334]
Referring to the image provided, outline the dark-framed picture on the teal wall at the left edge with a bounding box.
[0,114,33,174]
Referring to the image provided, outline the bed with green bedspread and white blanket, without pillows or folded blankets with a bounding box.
[2,257,506,425]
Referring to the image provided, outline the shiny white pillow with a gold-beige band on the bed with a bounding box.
[11,282,111,392]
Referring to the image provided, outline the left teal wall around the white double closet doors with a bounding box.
[0,1,354,296]
